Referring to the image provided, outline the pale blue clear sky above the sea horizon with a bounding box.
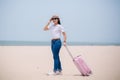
[0,0,120,44]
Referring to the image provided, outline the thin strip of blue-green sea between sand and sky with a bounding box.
[0,41,120,46]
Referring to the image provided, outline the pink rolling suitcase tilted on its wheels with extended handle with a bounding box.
[65,46,92,76]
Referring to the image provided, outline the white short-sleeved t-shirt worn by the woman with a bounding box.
[48,24,65,39]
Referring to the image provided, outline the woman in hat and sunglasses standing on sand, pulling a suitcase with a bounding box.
[44,15,66,75]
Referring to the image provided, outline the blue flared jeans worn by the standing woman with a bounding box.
[51,39,62,72]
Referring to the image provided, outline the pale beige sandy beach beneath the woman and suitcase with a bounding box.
[0,46,120,80]
